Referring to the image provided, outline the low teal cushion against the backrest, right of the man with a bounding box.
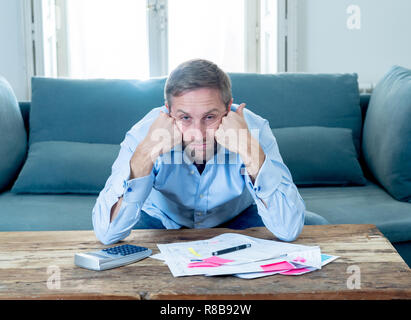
[273,127,366,186]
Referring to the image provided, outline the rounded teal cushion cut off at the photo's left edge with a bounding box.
[0,77,27,191]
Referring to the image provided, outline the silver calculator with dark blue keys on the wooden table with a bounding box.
[74,244,152,271]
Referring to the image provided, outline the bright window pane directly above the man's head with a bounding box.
[168,0,245,72]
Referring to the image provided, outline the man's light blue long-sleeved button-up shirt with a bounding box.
[93,105,305,244]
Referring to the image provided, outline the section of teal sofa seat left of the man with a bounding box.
[0,192,97,231]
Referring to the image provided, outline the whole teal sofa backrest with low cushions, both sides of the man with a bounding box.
[12,73,365,193]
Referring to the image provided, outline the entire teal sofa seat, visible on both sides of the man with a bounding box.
[0,180,411,242]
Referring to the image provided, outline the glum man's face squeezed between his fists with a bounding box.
[166,88,232,163]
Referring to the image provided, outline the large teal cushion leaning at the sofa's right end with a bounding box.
[362,66,411,201]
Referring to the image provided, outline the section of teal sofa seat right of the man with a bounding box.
[299,180,411,242]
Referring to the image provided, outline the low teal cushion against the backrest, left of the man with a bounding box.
[11,141,120,194]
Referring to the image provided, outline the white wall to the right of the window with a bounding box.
[297,0,411,83]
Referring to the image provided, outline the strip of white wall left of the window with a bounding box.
[0,0,28,101]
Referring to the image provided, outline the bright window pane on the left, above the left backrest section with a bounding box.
[67,0,149,78]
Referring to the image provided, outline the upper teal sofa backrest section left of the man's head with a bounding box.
[29,77,166,145]
